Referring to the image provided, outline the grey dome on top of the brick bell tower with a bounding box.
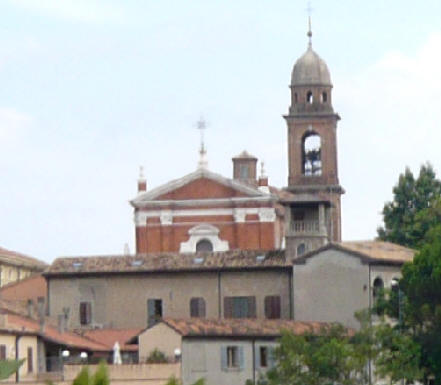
[291,46,332,86]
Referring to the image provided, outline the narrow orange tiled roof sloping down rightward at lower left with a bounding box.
[6,312,111,352]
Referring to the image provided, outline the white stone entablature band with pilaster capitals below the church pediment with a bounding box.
[134,207,276,227]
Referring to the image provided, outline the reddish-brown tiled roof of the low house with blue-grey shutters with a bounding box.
[156,318,330,337]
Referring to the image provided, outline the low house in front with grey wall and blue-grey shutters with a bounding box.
[138,318,328,385]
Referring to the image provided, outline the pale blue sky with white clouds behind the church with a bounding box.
[0,0,441,262]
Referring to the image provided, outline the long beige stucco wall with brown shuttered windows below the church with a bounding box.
[49,270,290,328]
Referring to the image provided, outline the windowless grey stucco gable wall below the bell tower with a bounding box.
[293,249,370,328]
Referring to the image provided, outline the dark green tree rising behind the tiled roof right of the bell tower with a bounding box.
[377,164,441,248]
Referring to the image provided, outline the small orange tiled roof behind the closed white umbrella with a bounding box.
[78,328,143,351]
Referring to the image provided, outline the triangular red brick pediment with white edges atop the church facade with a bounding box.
[131,169,271,207]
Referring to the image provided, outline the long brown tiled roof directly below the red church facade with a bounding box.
[44,250,290,276]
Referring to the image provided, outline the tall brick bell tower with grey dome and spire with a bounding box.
[284,23,344,258]
